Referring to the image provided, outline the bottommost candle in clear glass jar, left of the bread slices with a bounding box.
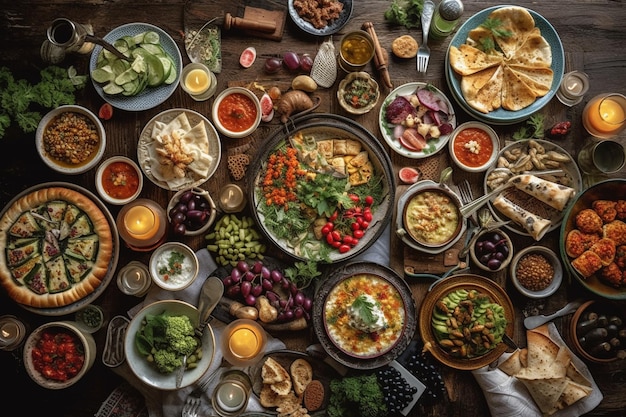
[211,369,252,417]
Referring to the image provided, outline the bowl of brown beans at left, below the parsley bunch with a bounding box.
[35,105,106,175]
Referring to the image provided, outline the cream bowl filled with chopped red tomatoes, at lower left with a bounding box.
[23,321,97,390]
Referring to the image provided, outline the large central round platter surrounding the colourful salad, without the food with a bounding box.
[247,113,395,263]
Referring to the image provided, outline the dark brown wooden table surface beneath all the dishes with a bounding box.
[0,0,626,417]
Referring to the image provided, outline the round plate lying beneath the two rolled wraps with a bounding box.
[484,139,583,236]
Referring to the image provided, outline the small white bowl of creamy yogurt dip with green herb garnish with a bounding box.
[149,242,199,291]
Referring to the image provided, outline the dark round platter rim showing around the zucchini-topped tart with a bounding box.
[0,182,120,316]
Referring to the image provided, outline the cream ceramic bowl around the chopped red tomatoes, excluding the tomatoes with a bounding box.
[24,321,97,390]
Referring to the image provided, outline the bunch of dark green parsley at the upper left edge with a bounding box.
[0,65,87,139]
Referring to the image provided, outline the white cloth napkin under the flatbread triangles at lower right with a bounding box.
[472,323,603,417]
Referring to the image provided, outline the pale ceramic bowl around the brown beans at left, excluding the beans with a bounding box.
[35,105,106,175]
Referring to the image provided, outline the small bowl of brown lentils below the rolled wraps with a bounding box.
[511,246,563,298]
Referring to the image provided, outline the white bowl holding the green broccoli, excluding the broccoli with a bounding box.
[124,300,215,391]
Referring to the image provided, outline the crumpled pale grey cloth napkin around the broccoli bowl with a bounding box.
[128,249,285,417]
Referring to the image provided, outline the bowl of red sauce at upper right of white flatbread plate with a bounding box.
[211,87,261,138]
